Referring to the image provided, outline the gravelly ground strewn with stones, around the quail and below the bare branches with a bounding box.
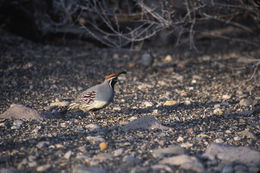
[0,33,260,173]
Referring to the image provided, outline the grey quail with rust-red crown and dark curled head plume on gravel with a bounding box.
[68,71,126,112]
